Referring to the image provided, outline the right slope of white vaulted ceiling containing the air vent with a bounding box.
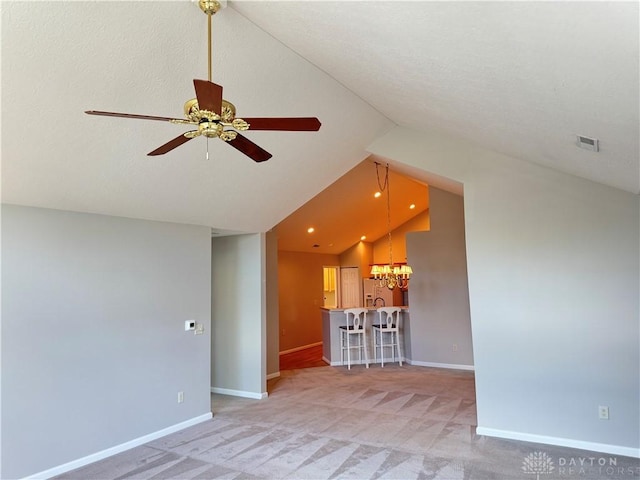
[233,1,640,193]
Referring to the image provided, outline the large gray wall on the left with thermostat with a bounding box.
[0,205,211,478]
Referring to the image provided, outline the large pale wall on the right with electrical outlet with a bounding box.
[369,128,640,456]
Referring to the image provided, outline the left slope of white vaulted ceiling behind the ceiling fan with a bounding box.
[0,1,393,232]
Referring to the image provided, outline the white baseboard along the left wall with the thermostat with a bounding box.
[24,412,213,480]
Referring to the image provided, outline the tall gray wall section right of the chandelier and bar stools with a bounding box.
[406,187,473,368]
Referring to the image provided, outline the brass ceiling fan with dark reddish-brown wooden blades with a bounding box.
[85,0,320,162]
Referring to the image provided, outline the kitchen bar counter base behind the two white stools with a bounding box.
[320,307,410,366]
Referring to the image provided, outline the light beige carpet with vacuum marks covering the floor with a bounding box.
[57,364,640,480]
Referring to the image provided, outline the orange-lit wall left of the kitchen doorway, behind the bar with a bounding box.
[278,250,340,352]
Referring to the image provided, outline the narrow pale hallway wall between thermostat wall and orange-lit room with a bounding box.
[211,234,267,398]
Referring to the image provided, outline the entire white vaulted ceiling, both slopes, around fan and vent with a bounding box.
[0,0,640,244]
